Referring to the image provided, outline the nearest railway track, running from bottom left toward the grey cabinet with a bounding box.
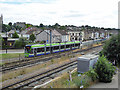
[2,60,77,90]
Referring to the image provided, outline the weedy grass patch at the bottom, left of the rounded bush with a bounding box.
[42,71,96,89]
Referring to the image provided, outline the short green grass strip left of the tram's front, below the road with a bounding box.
[0,53,24,60]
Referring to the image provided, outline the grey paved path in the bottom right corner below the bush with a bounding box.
[85,70,120,90]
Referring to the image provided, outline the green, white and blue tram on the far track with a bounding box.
[24,41,80,57]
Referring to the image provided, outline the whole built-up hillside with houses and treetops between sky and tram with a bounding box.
[0,15,118,48]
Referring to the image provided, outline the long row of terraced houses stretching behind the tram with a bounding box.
[0,27,118,47]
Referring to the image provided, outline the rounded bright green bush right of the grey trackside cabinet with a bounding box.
[95,56,115,82]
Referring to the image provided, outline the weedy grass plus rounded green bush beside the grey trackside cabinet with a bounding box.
[43,56,116,88]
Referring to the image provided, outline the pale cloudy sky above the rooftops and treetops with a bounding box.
[0,0,119,28]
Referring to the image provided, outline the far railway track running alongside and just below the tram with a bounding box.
[0,45,102,73]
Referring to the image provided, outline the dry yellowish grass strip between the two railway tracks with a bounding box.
[2,53,78,81]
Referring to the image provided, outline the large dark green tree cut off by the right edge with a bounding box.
[100,33,120,65]
